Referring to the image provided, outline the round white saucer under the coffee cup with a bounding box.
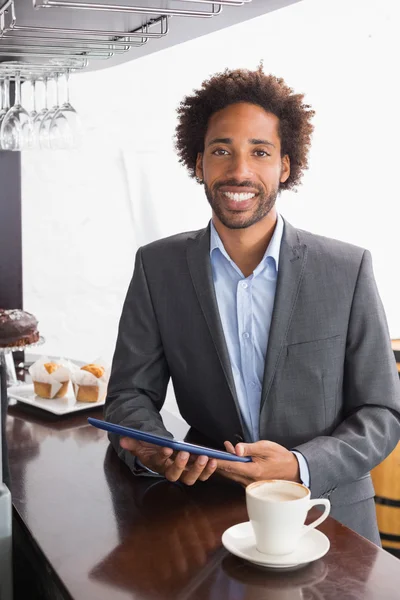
[222,521,330,569]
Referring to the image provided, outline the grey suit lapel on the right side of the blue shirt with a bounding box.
[260,221,307,410]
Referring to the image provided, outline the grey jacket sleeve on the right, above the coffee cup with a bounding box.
[294,250,400,497]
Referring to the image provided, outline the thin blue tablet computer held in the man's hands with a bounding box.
[88,417,251,462]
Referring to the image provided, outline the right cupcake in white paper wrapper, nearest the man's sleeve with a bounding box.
[72,363,108,403]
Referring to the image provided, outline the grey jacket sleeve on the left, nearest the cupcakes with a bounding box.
[104,248,173,471]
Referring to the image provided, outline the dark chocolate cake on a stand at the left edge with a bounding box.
[0,308,39,348]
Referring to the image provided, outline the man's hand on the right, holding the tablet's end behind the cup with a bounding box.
[217,440,301,486]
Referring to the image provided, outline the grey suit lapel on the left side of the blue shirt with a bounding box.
[187,225,243,429]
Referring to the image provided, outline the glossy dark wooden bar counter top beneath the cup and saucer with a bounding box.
[7,404,400,600]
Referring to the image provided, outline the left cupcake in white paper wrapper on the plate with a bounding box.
[29,358,70,400]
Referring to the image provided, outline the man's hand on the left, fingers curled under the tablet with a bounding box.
[120,437,217,485]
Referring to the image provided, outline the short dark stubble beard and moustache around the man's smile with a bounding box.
[204,181,279,229]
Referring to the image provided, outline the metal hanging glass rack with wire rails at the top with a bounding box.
[0,0,251,71]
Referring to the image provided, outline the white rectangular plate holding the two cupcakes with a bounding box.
[7,383,105,415]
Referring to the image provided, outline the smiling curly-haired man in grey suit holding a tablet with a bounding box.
[105,67,400,544]
